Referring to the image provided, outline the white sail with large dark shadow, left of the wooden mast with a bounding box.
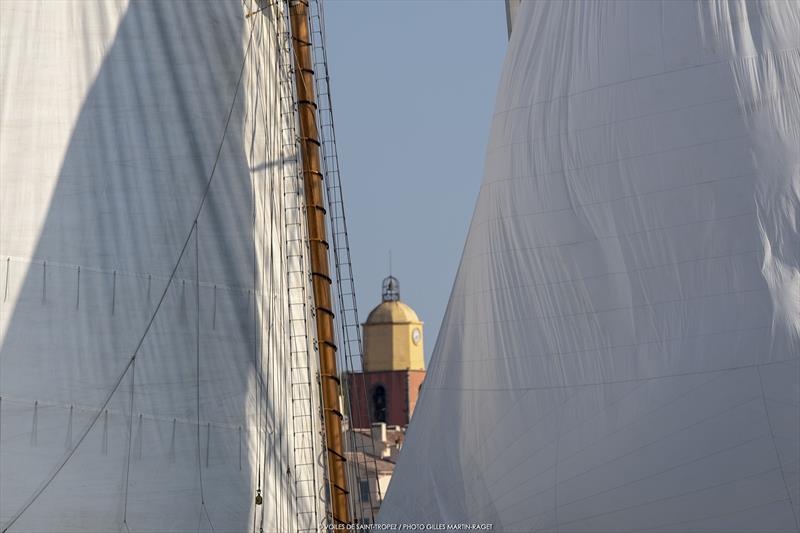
[0,0,324,532]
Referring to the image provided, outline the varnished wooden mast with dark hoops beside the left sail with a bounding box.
[289,0,350,524]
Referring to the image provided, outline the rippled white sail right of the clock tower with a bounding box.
[380,1,800,533]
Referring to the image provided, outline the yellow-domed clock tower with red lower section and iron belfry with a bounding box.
[348,276,425,428]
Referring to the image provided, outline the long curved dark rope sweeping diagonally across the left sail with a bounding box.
[0,20,253,533]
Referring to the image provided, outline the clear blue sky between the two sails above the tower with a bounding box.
[324,0,507,359]
